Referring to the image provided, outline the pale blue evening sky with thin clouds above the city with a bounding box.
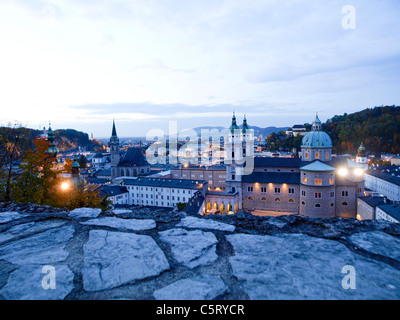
[0,0,400,138]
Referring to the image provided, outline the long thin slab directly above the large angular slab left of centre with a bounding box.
[81,217,156,231]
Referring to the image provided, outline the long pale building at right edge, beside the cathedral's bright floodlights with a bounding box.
[365,169,400,201]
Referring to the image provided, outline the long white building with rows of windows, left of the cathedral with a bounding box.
[121,177,207,208]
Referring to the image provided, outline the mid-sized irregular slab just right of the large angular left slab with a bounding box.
[159,228,218,268]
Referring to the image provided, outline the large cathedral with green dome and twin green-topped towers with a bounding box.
[203,115,364,218]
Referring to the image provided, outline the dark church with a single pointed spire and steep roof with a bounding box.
[109,121,150,180]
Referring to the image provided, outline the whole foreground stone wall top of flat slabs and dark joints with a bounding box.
[0,203,400,300]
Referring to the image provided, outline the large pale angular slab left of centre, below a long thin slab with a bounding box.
[82,230,170,291]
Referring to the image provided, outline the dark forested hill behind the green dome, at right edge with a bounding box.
[322,106,400,154]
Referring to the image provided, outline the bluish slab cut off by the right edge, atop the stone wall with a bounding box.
[348,231,400,261]
